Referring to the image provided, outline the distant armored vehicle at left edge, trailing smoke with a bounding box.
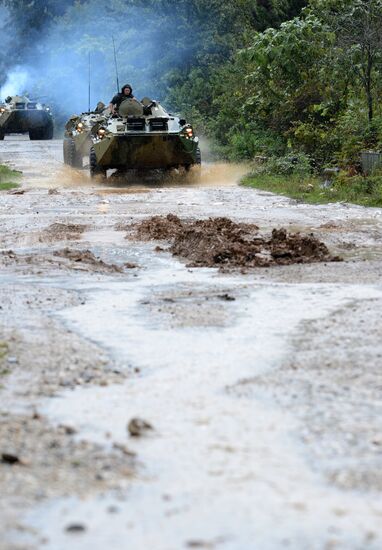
[0,96,53,140]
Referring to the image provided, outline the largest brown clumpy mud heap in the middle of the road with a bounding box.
[134,214,339,268]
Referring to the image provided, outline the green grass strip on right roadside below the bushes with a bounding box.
[242,174,382,206]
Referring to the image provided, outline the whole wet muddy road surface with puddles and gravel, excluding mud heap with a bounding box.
[0,138,382,550]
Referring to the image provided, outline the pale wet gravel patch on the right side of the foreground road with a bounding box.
[227,299,382,494]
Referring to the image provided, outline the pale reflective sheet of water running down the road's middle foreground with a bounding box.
[11,250,382,550]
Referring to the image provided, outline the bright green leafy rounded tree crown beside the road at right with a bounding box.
[236,15,340,159]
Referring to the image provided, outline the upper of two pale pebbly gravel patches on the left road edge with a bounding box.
[0,284,124,402]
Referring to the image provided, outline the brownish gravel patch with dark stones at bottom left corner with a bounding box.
[0,416,135,549]
